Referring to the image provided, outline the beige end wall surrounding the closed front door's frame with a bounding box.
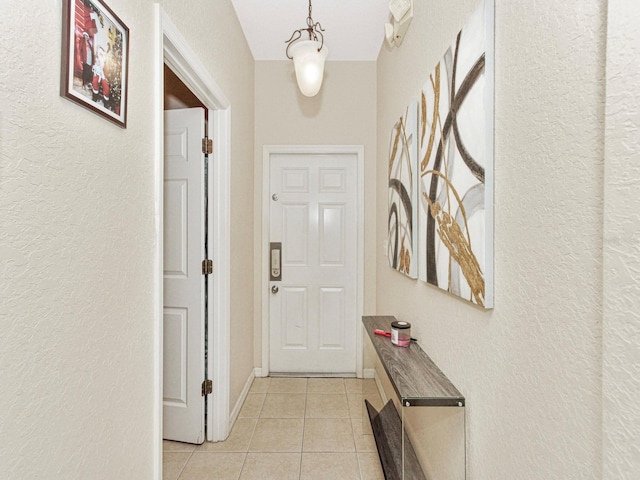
[254,61,376,368]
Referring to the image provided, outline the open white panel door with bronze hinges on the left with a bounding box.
[163,108,205,443]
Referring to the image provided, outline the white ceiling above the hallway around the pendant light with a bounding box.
[231,0,389,61]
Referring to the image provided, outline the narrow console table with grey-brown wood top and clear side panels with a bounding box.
[362,316,465,480]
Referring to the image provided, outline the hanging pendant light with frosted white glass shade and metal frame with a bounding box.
[285,0,329,97]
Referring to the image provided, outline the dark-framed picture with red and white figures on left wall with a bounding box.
[60,0,129,128]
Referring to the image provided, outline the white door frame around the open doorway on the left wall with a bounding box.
[153,4,231,472]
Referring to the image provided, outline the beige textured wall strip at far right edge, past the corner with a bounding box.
[602,0,640,480]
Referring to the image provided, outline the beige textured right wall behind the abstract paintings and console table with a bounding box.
[376,0,606,480]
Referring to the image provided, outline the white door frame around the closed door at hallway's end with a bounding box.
[260,145,364,378]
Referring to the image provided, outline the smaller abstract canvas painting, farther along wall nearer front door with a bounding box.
[387,102,418,278]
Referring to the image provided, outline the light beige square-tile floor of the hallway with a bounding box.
[163,378,384,480]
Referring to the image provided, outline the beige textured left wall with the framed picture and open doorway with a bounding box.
[0,0,253,480]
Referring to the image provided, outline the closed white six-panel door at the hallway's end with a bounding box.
[269,153,358,374]
